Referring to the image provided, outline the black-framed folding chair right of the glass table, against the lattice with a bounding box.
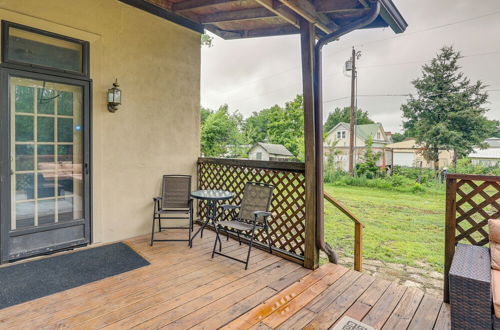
[212,182,274,269]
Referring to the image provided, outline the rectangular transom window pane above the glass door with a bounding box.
[7,27,83,73]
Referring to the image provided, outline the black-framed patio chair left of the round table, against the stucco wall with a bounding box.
[151,175,193,246]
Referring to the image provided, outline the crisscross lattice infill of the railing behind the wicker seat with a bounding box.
[455,179,500,245]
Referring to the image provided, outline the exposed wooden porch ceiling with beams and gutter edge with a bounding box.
[120,0,407,39]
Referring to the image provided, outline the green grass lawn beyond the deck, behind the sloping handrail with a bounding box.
[325,184,445,272]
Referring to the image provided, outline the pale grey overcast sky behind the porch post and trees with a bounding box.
[201,0,500,131]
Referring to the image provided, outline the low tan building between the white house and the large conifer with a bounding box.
[387,138,453,169]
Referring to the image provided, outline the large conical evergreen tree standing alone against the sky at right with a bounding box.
[401,47,494,171]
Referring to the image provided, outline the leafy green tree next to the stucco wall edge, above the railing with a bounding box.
[201,104,242,157]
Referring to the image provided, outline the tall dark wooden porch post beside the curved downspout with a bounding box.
[300,18,322,269]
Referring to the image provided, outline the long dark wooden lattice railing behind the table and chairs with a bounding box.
[198,158,305,260]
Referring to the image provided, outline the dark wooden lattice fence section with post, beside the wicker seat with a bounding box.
[444,174,500,302]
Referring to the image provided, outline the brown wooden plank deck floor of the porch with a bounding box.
[0,228,450,329]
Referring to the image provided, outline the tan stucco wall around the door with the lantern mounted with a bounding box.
[0,0,200,242]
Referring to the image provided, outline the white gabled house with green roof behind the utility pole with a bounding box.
[323,122,392,171]
